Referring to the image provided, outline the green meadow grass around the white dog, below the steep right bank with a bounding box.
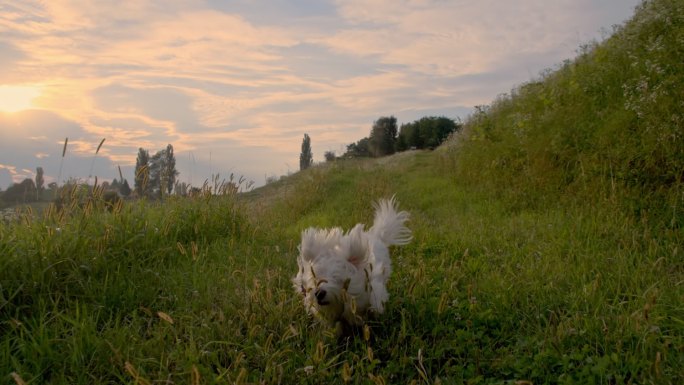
[0,152,684,384]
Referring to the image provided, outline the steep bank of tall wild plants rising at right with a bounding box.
[446,0,684,216]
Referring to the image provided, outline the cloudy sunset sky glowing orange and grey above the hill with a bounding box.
[0,0,640,190]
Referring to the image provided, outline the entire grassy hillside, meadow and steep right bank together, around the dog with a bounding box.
[0,0,684,384]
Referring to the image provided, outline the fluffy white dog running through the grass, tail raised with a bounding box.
[292,198,411,325]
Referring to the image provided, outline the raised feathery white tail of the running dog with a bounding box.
[369,197,411,246]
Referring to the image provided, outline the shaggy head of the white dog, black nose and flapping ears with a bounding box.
[292,229,366,321]
